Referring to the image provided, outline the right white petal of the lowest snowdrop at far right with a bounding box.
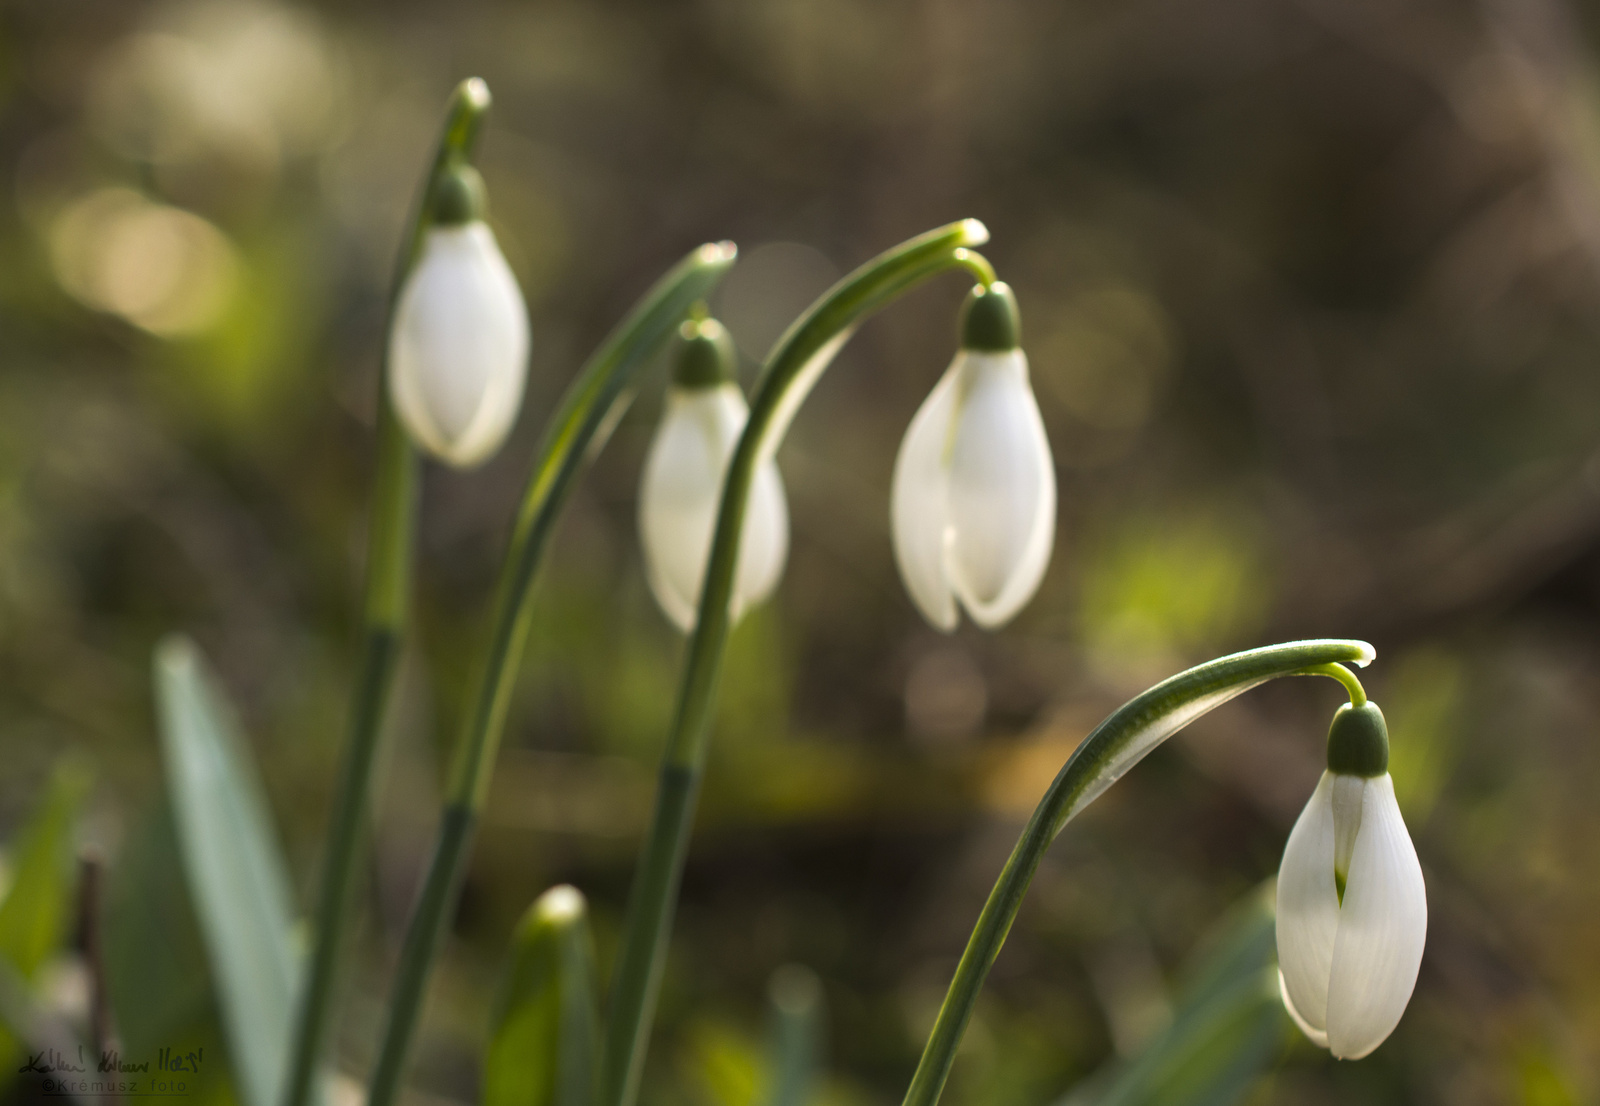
[1328,775,1427,1060]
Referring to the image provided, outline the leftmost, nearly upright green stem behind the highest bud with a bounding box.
[286,78,490,1106]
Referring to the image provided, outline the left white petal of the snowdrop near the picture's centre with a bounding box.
[890,354,963,632]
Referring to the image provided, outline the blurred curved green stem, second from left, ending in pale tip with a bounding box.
[368,242,734,1106]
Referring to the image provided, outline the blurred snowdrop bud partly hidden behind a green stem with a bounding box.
[638,319,789,632]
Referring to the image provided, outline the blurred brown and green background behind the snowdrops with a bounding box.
[0,0,1600,1106]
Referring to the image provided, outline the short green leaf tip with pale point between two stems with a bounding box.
[483,885,600,1106]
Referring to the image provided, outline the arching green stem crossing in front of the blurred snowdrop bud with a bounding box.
[601,219,994,1106]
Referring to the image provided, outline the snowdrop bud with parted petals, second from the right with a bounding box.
[890,283,1056,632]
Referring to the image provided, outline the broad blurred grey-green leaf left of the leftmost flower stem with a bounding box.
[155,637,299,1106]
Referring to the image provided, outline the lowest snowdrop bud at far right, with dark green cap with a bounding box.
[1278,703,1427,1060]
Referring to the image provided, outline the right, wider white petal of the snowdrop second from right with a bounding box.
[947,349,1056,629]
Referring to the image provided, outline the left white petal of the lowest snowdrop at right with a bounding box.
[1277,771,1339,1036]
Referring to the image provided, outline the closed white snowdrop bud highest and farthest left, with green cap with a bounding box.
[389,165,528,467]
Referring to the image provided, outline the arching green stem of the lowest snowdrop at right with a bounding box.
[906,640,1373,1106]
